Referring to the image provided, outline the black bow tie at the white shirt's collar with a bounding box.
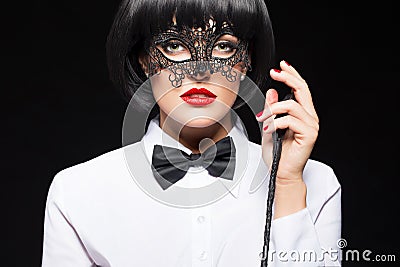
[151,136,236,190]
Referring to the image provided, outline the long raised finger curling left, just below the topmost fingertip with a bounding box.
[270,69,318,119]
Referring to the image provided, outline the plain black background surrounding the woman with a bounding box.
[1,0,400,266]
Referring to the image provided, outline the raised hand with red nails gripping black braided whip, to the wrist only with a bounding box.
[256,61,319,184]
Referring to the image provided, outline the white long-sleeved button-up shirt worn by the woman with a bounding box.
[42,120,341,267]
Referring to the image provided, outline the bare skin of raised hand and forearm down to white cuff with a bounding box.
[257,61,319,219]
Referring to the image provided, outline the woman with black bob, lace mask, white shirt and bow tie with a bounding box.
[42,0,341,266]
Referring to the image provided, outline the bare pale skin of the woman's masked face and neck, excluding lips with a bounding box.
[139,30,246,153]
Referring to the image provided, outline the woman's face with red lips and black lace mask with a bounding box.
[142,17,250,127]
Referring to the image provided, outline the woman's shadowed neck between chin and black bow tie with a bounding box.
[160,111,232,153]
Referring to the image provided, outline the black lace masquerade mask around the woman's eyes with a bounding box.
[145,20,251,87]
